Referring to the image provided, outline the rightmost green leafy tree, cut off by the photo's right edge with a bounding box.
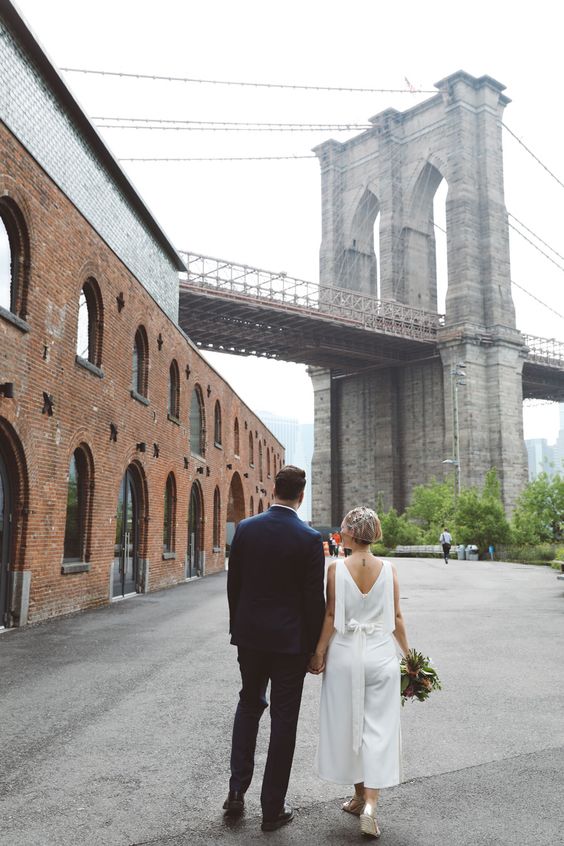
[513,472,564,544]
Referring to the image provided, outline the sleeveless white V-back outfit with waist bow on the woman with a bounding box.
[317,560,401,789]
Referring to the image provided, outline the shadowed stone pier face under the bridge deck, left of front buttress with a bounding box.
[309,356,447,526]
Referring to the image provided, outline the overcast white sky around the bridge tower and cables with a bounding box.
[17,0,564,440]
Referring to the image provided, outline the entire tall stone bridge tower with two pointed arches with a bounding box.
[310,71,526,525]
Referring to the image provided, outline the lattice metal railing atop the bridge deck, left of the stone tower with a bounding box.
[179,250,444,341]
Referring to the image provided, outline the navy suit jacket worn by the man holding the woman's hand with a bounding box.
[227,505,325,654]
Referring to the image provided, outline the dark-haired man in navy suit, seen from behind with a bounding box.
[223,465,325,831]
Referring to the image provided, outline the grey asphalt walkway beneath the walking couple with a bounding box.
[0,559,564,846]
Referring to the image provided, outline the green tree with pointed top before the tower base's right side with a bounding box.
[453,467,511,555]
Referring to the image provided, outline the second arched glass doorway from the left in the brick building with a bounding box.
[112,465,142,599]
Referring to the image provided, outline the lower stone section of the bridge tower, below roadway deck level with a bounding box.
[309,332,527,526]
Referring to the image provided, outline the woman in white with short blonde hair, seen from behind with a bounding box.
[309,506,409,837]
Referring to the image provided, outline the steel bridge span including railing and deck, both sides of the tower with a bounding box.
[180,251,564,392]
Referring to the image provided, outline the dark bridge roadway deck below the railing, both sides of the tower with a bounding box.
[179,283,564,402]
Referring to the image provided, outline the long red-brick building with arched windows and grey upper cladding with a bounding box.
[0,3,284,626]
